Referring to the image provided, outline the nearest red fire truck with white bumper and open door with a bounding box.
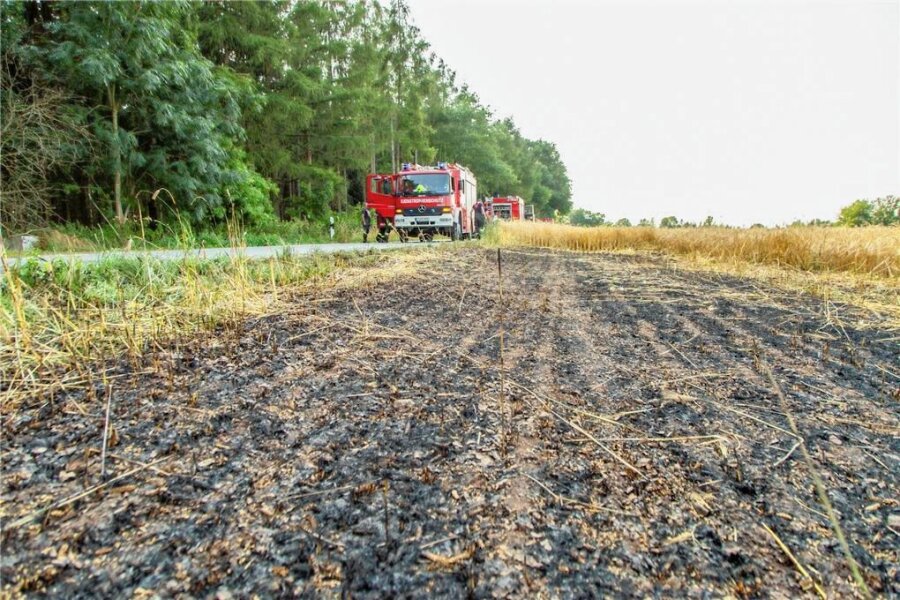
[366,163,478,242]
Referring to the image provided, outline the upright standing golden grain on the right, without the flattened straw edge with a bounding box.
[499,223,900,278]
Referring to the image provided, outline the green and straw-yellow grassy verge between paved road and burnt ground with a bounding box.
[0,246,432,413]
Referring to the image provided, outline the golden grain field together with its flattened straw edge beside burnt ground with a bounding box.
[486,223,900,327]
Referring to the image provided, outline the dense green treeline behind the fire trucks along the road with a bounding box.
[0,0,571,231]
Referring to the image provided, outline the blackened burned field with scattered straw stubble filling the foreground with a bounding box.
[0,248,900,598]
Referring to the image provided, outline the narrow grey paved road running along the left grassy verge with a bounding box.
[0,242,445,272]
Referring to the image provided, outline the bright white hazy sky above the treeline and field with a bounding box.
[409,0,900,225]
